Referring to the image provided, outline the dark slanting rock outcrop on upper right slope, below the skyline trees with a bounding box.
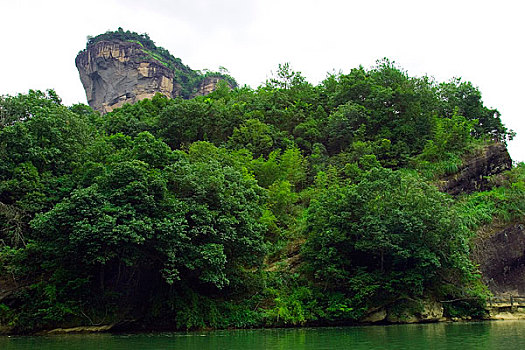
[440,143,512,195]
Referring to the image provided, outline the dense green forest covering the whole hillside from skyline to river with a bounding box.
[0,59,525,333]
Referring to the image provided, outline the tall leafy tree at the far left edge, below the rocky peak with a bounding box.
[0,90,97,247]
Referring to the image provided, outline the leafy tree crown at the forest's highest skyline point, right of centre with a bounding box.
[324,59,438,164]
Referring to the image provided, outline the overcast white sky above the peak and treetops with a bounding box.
[0,0,525,161]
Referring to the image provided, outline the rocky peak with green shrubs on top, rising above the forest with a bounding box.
[75,29,236,114]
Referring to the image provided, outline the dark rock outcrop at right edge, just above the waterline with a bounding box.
[472,222,525,295]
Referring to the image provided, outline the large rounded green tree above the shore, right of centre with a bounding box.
[303,168,473,314]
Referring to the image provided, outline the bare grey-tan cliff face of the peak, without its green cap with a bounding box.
[75,40,229,114]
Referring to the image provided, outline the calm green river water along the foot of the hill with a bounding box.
[0,321,525,350]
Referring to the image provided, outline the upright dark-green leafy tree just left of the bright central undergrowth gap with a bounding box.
[164,152,265,287]
